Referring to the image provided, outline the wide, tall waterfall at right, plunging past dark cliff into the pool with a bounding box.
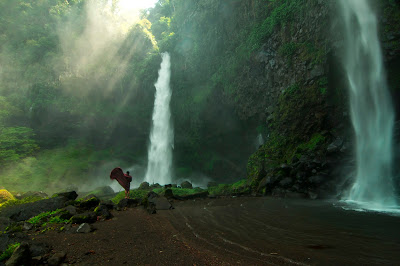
[339,0,397,210]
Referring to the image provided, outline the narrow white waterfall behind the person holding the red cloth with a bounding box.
[145,53,173,184]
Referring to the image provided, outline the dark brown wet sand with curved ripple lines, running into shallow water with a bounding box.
[34,197,400,265]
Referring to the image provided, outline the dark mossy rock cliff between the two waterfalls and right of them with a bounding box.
[149,0,400,189]
